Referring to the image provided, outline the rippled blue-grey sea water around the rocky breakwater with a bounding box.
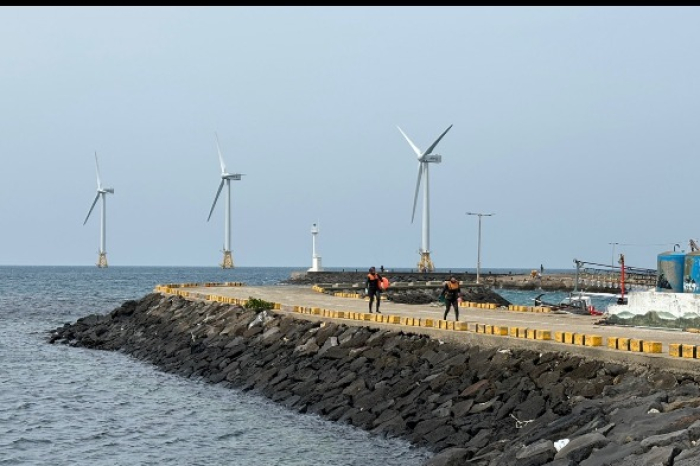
[0,266,616,466]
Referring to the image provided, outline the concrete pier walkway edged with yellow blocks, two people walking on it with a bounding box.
[160,284,700,374]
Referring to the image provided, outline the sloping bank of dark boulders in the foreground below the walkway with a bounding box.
[47,293,700,466]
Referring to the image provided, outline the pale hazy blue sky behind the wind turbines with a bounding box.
[0,6,700,270]
